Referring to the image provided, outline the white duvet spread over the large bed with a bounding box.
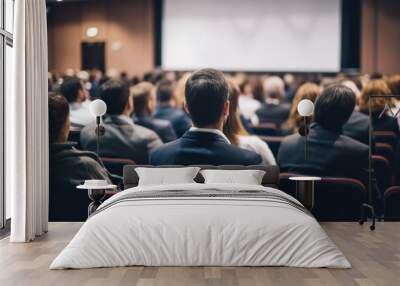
[50,184,351,269]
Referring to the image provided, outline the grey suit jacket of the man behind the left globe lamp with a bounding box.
[80,115,162,164]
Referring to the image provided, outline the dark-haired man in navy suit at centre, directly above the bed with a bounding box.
[150,69,261,165]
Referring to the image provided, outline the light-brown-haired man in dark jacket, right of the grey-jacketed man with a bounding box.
[131,82,177,142]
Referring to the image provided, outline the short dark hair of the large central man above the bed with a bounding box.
[185,69,229,127]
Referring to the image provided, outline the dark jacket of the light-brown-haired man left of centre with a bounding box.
[135,116,177,143]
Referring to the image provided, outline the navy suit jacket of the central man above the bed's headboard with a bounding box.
[150,131,261,165]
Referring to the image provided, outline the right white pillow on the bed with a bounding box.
[200,170,265,185]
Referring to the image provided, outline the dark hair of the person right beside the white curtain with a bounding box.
[49,93,69,144]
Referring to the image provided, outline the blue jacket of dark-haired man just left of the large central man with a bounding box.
[153,106,192,137]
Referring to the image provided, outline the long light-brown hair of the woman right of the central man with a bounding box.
[223,79,249,146]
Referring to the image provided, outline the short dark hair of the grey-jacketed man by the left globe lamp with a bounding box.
[98,80,130,115]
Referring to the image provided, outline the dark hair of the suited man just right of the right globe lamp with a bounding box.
[314,84,356,131]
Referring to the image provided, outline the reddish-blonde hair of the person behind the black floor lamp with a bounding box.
[359,79,393,113]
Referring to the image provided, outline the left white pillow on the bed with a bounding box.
[135,167,200,186]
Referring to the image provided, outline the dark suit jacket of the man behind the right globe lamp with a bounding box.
[278,123,368,182]
